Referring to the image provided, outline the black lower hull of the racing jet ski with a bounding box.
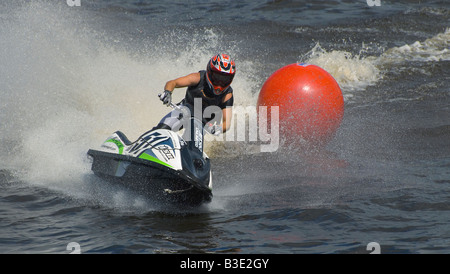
[88,149,212,206]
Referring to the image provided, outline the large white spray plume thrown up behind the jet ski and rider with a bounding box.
[0,1,255,195]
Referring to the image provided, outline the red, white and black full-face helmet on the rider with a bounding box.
[206,54,236,95]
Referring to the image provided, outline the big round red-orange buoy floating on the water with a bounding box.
[257,63,344,146]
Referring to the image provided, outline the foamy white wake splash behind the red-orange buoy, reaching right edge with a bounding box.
[300,28,450,96]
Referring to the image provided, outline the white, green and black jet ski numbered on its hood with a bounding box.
[87,101,212,206]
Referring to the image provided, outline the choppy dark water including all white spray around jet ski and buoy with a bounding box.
[0,0,450,254]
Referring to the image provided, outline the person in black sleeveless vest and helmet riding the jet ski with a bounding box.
[156,54,236,135]
